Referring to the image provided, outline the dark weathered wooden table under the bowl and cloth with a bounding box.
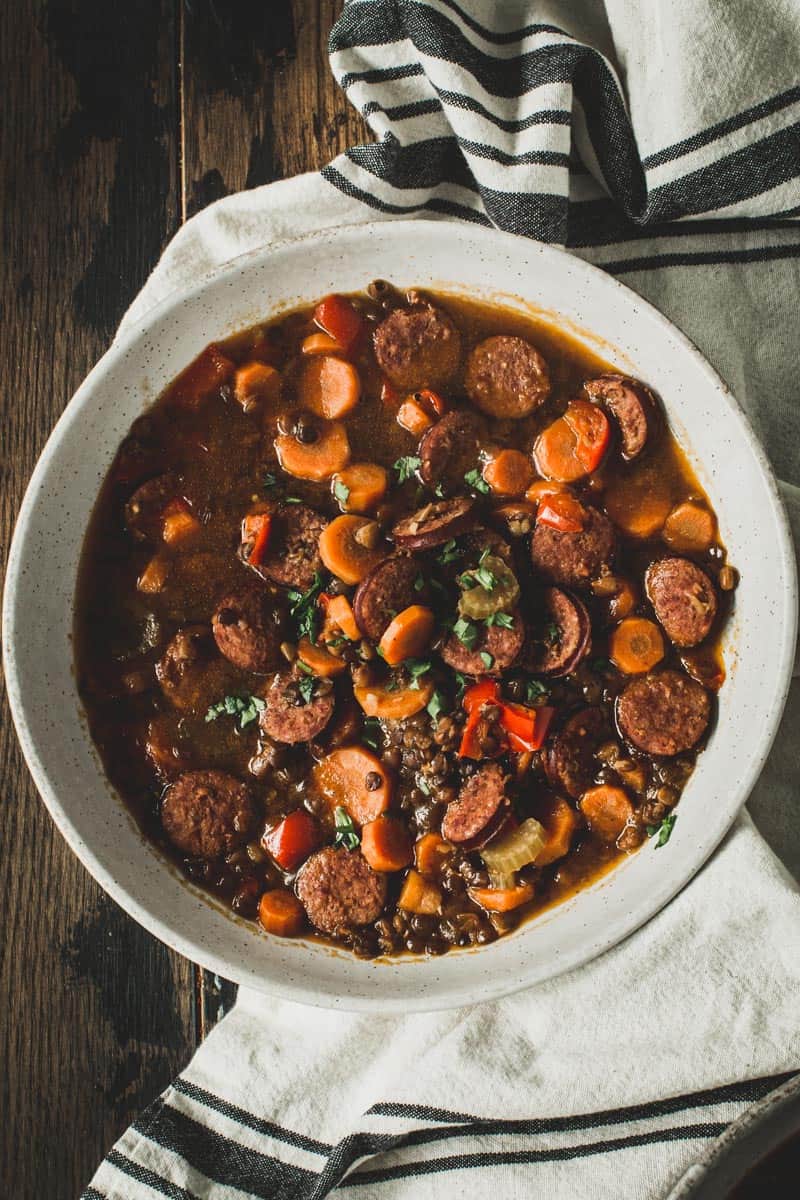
[0,7,365,1200]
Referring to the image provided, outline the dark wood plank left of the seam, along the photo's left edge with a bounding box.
[0,0,194,1200]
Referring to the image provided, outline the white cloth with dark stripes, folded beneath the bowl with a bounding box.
[84,0,800,1200]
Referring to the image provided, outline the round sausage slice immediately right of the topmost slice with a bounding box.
[464,336,551,419]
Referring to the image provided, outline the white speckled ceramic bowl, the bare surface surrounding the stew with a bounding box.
[4,221,796,1012]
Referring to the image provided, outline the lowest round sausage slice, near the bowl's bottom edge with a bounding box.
[296,846,386,934]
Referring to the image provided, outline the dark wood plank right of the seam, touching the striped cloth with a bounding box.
[181,0,368,1037]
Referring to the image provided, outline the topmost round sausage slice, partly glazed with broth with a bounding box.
[373,301,461,391]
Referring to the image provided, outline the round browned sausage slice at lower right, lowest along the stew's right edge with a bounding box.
[616,671,711,755]
